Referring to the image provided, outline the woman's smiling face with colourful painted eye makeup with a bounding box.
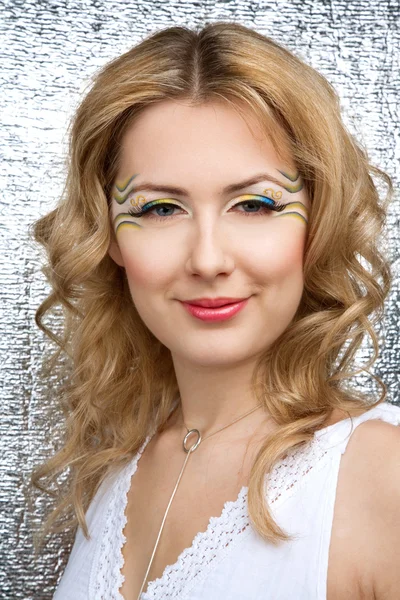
[109,101,309,366]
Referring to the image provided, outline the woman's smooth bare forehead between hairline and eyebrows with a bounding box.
[119,100,295,180]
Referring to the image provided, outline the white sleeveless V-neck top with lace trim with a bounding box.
[53,402,400,600]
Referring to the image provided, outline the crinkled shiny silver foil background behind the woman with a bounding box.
[0,0,400,600]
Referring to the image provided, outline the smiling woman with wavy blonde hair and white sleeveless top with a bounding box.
[34,23,400,600]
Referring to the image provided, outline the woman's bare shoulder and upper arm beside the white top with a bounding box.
[343,419,400,600]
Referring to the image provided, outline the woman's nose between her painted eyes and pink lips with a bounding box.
[186,215,235,280]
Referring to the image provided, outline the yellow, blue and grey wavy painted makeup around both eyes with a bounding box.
[113,171,308,234]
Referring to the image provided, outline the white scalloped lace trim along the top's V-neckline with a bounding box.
[90,422,328,600]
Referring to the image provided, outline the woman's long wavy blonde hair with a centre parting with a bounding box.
[32,22,392,543]
